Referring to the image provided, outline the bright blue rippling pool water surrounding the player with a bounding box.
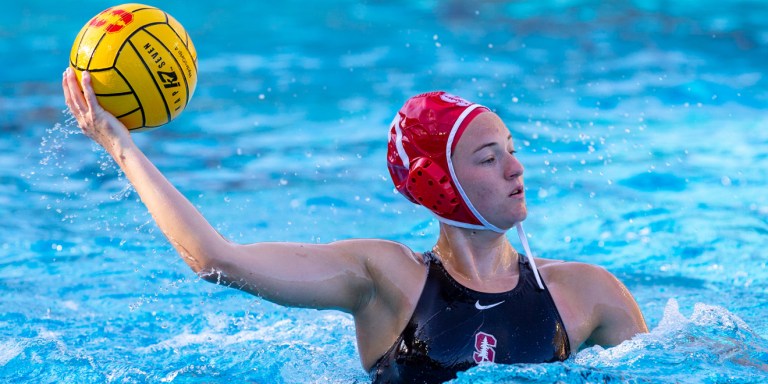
[0,0,768,383]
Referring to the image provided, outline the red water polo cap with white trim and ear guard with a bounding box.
[387,91,505,233]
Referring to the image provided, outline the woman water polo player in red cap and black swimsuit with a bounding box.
[62,70,647,382]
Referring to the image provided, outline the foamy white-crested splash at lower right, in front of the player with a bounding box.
[455,299,768,383]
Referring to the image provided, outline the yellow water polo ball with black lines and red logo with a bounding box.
[69,4,197,130]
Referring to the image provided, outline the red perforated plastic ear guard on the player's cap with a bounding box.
[405,157,459,216]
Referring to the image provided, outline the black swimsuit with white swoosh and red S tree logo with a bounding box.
[370,252,571,383]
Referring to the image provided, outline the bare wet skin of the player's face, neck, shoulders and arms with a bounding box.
[62,71,647,369]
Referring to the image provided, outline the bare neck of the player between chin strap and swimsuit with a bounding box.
[434,223,519,281]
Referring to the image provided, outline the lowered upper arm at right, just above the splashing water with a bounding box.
[586,266,648,347]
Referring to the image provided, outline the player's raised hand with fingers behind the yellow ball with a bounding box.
[61,68,131,151]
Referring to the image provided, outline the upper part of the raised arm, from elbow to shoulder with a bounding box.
[203,240,402,313]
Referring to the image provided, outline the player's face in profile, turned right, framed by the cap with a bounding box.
[451,112,528,229]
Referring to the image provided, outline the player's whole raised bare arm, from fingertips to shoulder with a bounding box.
[62,69,408,312]
